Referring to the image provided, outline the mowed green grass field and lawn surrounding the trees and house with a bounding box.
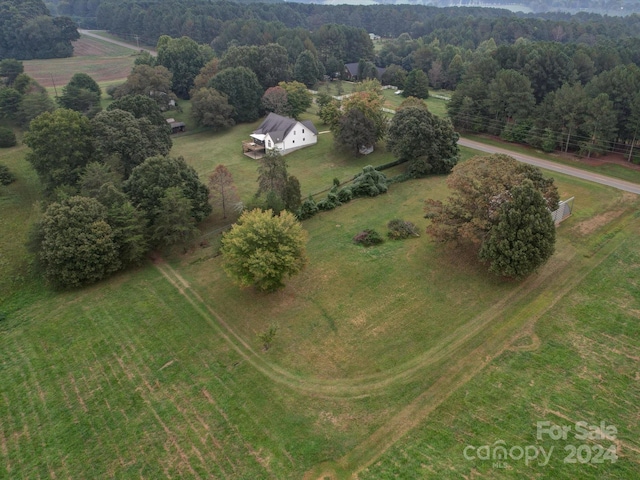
[0,44,640,479]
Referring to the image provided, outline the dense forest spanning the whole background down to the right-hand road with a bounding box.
[3,0,640,160]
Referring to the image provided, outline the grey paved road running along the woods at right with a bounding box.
[458,138,640,195]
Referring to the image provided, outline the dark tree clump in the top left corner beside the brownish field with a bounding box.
[0,0,80,60]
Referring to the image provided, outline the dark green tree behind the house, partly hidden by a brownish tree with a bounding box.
[209,67,263,122]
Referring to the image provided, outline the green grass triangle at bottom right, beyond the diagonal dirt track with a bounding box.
[360,222,640,479]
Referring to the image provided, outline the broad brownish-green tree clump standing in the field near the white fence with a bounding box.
[426,154,558,276]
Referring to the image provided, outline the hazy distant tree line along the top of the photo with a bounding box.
[91,0,640,49]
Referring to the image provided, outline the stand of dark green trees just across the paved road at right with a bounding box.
[447,40,640,160]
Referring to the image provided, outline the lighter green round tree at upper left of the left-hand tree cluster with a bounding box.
[24,108,94,193]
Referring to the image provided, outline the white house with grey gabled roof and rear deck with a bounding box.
[242,113,318,158]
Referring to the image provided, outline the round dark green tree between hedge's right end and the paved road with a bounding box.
[387,101,459,175]
